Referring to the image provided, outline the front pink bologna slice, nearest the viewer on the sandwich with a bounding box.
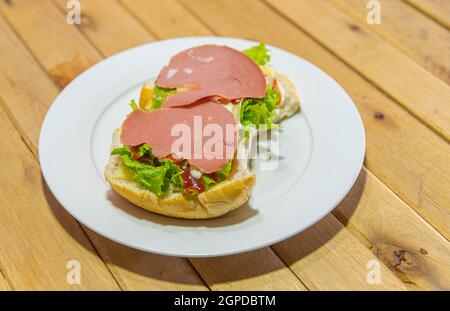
[120,100,237,174]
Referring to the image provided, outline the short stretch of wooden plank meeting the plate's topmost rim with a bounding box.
[119,0,210,38]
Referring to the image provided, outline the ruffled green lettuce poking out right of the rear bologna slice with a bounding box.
[241,86,280,129]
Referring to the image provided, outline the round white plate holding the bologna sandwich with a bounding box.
[39,37,365,257]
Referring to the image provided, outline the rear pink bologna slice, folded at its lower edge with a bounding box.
[156,45,266,107]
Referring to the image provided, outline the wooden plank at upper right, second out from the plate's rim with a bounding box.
[267,0,450,141]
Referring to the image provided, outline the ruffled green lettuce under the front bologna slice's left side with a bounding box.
[111,144,183,196]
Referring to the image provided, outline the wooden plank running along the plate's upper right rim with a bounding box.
[181,0,450,288]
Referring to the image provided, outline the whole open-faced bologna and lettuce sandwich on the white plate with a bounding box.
[105,44,300,219]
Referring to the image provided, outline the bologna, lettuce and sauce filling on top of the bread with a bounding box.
[112,44,282,196]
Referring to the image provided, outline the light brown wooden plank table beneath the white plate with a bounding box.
[0,0,450,290]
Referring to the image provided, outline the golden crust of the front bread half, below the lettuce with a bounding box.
[105,129,256,219]
